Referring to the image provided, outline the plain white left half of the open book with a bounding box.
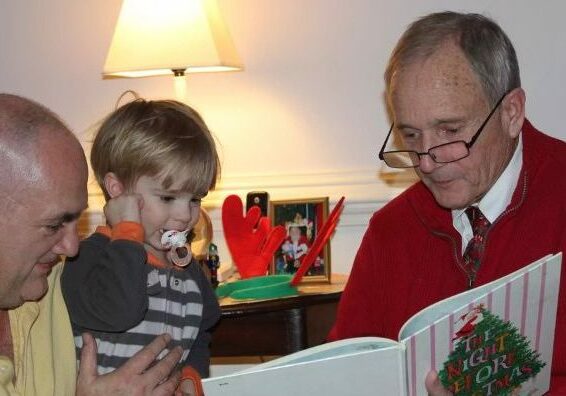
[203,337,406,396]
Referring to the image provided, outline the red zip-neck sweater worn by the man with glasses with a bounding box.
[329,121,566,395]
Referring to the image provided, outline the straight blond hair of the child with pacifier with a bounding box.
[90,99,220,199]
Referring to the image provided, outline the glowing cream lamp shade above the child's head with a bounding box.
[103,0,242,77]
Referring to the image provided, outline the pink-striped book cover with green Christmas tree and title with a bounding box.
[399,254,562,396]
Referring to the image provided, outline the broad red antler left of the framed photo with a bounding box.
[222,195,286,279]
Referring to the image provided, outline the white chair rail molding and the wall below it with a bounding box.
[80,169,422,273]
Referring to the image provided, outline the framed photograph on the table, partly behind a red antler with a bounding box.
[269,197,330,282]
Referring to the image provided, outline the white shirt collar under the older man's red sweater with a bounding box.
[452,134,523,254]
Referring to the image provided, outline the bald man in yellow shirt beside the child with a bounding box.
[0,94,181,396]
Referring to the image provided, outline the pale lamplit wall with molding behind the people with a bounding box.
[0,0,566,272]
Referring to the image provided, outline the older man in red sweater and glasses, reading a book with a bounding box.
[329,12,566,395]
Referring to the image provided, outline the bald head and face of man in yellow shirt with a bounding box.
[0,94,88,308]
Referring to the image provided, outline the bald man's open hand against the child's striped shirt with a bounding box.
[76,333,182,396]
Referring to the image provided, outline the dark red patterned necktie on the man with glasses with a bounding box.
[463,206,491,288]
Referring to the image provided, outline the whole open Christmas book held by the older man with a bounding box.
[203,253,562,396]
